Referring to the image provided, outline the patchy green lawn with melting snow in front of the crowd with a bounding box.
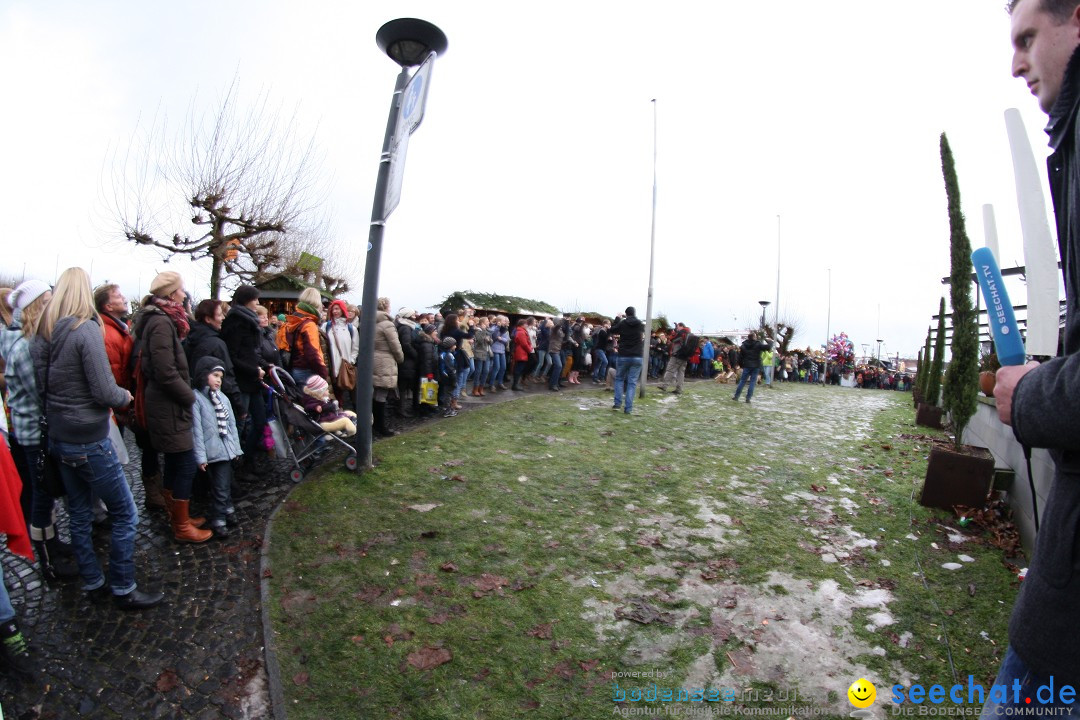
[263,382,1017,719]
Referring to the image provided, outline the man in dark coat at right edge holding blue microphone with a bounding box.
[983,0,1080,717]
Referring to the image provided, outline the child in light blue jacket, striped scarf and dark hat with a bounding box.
[191,355,244,538]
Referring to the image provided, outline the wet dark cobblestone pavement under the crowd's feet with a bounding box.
[0,379,652,720]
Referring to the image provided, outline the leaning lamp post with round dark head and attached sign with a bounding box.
[356,17,447,468]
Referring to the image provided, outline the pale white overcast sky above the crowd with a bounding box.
[0,0,1062,356]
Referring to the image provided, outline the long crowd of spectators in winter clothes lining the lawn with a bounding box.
[0,273,915,638]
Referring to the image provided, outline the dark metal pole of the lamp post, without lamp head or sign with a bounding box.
[356,67,409,468]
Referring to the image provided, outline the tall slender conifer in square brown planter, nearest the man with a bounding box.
[919,133,994,510]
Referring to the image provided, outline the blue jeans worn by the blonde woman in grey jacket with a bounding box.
[49,437,139,595]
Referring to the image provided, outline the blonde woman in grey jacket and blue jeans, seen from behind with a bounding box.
[30,268,164,610]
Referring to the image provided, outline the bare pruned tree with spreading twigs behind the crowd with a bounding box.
[113,80,326,298]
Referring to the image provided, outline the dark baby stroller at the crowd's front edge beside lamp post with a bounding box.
[262,367,357,483]
